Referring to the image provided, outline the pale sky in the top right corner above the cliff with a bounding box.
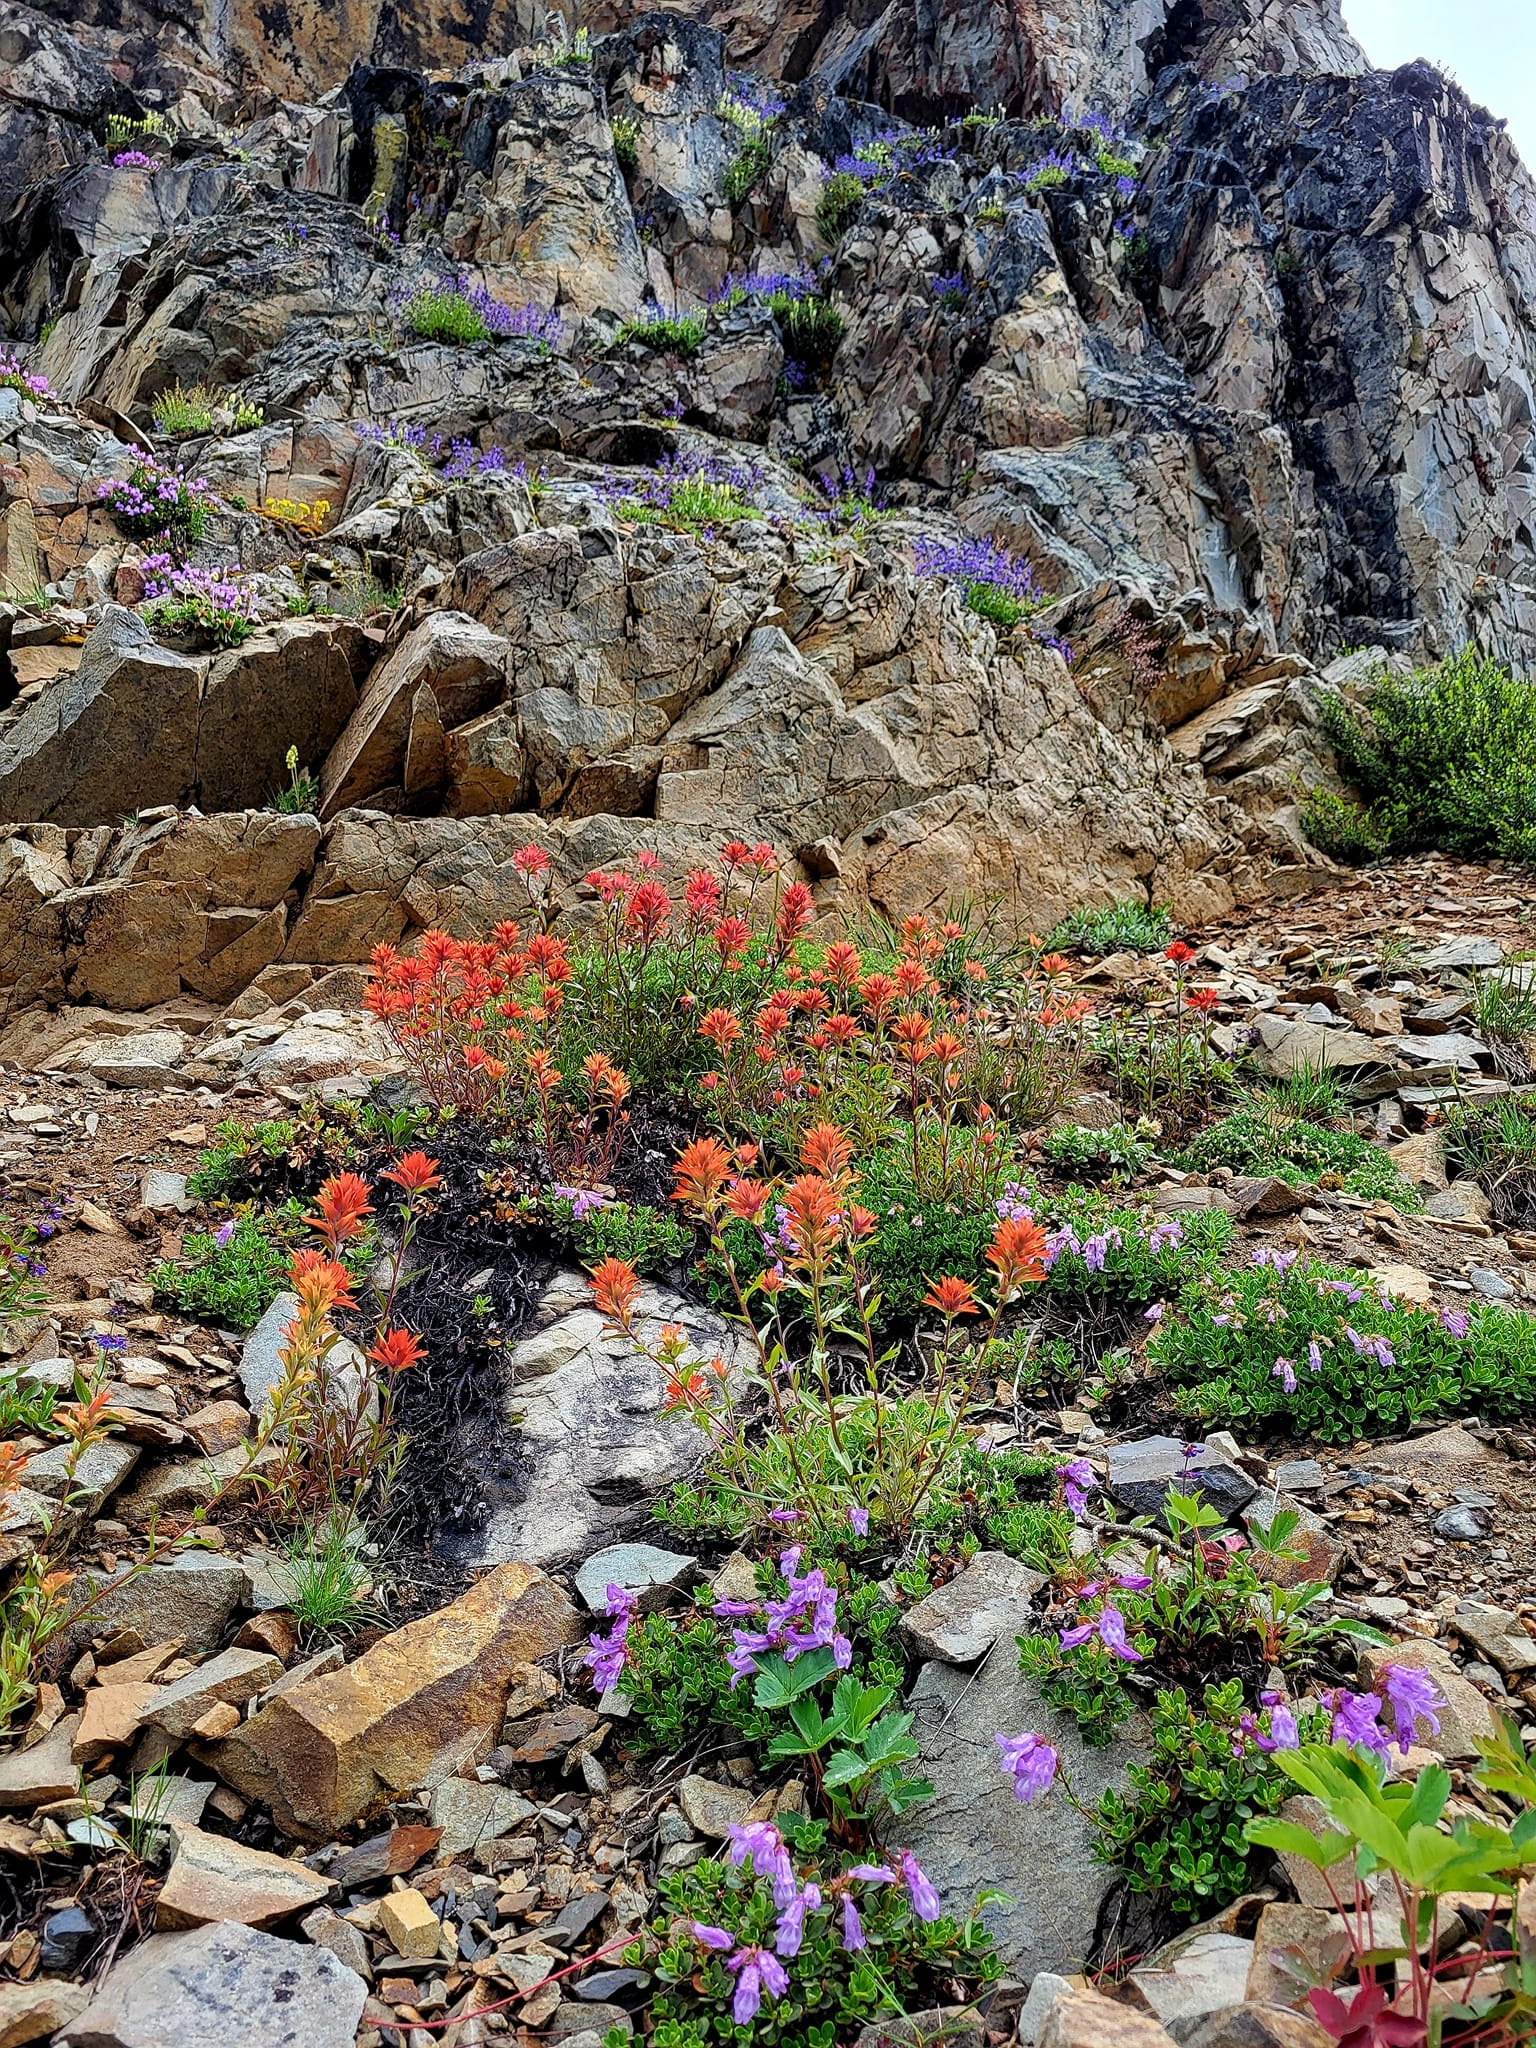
[1343,0,1536,168]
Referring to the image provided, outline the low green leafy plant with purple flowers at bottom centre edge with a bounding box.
[623,1825,1001,2048]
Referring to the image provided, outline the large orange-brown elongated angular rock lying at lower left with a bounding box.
[211,1563,584,1839]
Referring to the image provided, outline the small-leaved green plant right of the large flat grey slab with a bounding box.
[1094,1679,1292,1921]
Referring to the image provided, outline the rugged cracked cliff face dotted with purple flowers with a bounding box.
[0,0,1536,1019]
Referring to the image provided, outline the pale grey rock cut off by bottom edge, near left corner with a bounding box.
[59,1921,369,2048]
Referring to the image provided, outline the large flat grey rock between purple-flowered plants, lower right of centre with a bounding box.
[901,1642,1147,1974]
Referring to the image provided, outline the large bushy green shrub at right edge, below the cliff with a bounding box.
[1307,647,1536,862]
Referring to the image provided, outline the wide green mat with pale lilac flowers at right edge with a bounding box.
[1147,1251,1536,1444]
